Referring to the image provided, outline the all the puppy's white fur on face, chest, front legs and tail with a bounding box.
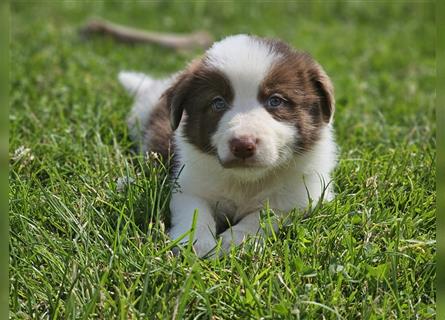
[120,35,336,256]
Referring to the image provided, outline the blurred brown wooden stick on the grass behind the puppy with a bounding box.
[81,19,213,50]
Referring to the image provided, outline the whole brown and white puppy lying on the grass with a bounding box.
[119,35,336,256]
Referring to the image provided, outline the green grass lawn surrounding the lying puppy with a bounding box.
[9,1,436,319]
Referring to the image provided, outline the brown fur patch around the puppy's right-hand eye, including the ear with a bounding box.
[258,40,334,152]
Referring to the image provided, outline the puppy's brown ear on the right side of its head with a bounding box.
[313,66,335,123]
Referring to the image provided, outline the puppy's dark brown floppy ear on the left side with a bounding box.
[163,71,191,131]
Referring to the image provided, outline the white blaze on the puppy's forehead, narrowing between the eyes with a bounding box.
[206,34,280,98]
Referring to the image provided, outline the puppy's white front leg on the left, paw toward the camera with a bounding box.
[169,193,216,257]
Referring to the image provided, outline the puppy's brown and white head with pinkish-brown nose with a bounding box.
[165,35,334,180]
